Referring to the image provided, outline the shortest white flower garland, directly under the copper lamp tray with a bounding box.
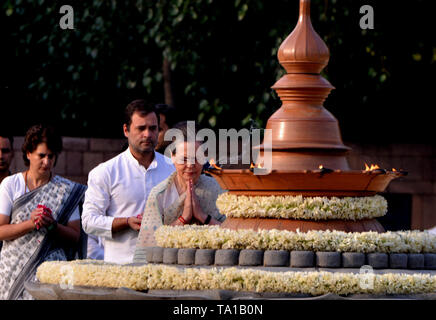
[216,193,388,220]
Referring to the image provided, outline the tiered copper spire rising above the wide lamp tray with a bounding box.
[266,0,350,170]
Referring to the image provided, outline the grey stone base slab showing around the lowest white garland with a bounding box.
[29,263,436,300]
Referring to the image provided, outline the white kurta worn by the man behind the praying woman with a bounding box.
[82,148,175,263]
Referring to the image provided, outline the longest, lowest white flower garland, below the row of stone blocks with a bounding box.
[36,260,436,296]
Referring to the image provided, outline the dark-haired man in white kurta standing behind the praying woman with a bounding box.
[82,100,175,263]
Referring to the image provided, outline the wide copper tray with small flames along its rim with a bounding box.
[207,169,407,197]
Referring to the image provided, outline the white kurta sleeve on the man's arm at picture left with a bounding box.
[82,166,114,239]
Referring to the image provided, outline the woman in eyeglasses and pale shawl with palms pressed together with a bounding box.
[133,123,225,262]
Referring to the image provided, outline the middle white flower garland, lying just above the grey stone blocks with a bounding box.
[155,225,436,253]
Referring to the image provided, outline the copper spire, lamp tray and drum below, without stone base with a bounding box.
[206,1,404,232]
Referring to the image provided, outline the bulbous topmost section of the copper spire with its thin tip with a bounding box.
[277,0,330,74]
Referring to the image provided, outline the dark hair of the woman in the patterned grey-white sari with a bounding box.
[21,124,62,167]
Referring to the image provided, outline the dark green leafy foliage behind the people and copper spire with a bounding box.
[0,0,436,141]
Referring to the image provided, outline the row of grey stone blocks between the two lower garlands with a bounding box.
[141,247,436,271]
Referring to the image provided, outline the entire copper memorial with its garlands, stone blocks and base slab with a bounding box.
[30,0,436,299]
